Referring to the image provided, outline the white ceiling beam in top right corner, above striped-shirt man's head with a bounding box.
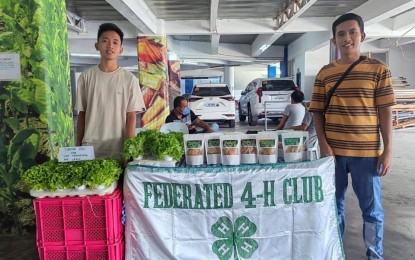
[351,0,415,25]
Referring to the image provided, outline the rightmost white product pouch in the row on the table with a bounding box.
[282,131,303,162]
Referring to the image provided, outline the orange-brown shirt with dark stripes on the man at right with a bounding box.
[309,58,396,157]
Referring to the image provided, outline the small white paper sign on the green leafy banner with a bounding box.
[0,53,22,81]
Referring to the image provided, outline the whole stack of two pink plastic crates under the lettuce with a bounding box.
[34,189,124,260]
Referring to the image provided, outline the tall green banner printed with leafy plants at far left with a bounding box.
[0,0,74,234]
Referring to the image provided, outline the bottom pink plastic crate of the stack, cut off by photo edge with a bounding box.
[38,240,124,260]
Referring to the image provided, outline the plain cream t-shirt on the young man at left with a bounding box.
[75,66,145,159]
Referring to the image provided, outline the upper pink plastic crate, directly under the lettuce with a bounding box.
[33,189,123,247]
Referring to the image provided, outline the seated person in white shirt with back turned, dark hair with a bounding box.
[277,90,305,130]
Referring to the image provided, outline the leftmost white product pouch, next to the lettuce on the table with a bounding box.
[183,134,204,165]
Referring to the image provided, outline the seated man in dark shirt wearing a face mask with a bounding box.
[166,96,219,134]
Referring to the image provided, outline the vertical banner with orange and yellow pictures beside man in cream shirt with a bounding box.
[137,36,169,129]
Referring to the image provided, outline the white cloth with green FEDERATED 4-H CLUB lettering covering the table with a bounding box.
[124,157,344,260]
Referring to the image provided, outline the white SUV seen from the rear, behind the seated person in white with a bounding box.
[238,78,297,126]
